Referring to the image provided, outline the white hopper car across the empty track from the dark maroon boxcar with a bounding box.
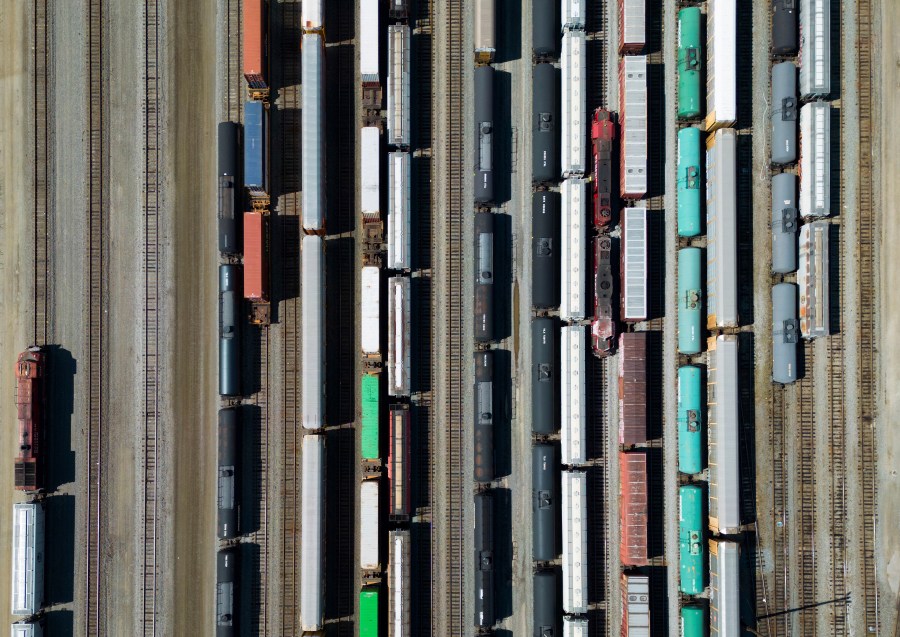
[560,325,587,466]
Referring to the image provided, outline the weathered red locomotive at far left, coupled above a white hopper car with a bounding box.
[15,347,47,491]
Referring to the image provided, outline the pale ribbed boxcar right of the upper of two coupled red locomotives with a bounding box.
[619,56,648,199]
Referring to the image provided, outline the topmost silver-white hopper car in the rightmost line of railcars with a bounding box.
[800,0,831,99]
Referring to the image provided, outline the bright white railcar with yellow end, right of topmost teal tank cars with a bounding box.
[704,0,737,132]
